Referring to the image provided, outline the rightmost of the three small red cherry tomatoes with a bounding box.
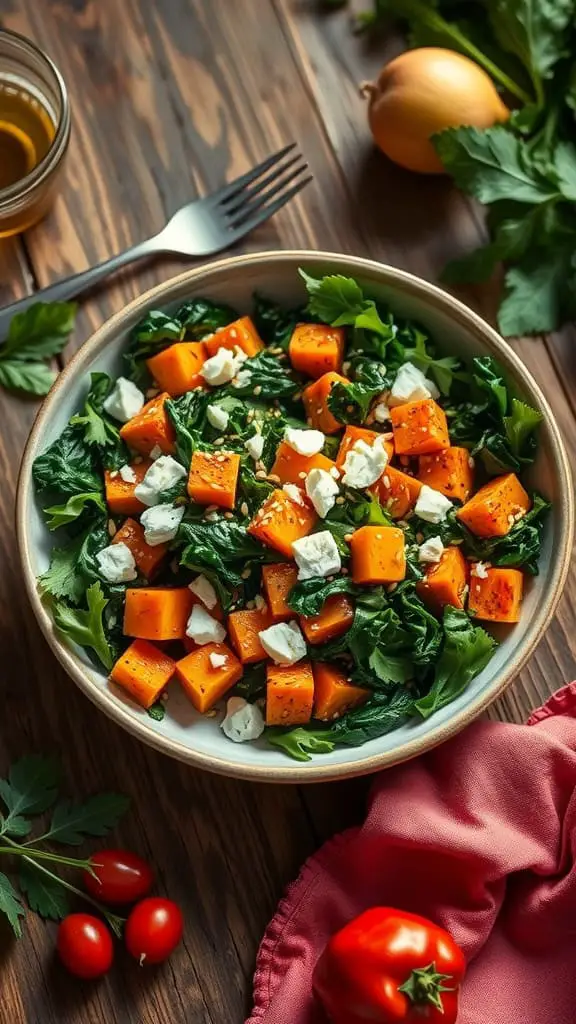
[124,896,183,965]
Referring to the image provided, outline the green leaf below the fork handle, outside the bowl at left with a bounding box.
[0,302,76,395]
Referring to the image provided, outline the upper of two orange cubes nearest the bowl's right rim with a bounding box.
[456,473,531,537]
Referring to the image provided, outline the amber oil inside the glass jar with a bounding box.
[0,72,56,189]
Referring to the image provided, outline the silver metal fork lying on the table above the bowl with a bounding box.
[0,142,312,338]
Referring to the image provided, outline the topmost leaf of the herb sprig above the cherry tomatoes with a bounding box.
[0,755,60,836]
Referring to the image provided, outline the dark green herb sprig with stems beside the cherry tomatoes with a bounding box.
[0,755,128,937]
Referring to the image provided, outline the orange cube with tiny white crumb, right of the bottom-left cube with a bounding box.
[175,643,242,715]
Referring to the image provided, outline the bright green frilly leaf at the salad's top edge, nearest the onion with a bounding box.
[298,267,392,339]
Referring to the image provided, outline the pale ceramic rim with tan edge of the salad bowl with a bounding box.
[15,249,574,783]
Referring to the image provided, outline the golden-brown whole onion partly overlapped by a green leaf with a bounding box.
[362,46,510,174]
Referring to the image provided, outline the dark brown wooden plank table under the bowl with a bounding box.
[0,0,576,1024]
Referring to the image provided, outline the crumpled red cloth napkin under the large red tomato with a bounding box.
[247,682,576,1024]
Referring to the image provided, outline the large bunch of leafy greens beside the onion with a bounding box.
[344,0,576,336]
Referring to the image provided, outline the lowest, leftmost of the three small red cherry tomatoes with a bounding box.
[56,913,114,978]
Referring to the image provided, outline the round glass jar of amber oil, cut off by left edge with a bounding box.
[0,31,71,238]
